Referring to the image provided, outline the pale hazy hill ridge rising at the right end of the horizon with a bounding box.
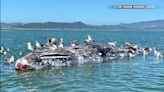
[119,20,164,28]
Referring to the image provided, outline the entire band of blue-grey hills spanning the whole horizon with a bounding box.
[1,20,164,31]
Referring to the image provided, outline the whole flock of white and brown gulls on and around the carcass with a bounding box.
[0,35,164,64]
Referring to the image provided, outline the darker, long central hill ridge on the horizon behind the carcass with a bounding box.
[12,22,128,30]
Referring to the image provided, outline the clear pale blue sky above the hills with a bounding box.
[1,0,164,25]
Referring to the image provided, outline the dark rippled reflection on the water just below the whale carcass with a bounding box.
[15,59,121,78]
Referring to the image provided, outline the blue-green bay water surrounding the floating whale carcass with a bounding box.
[0,30,164,92]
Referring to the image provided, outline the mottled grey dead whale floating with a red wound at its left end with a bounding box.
[15,44,142,69]
